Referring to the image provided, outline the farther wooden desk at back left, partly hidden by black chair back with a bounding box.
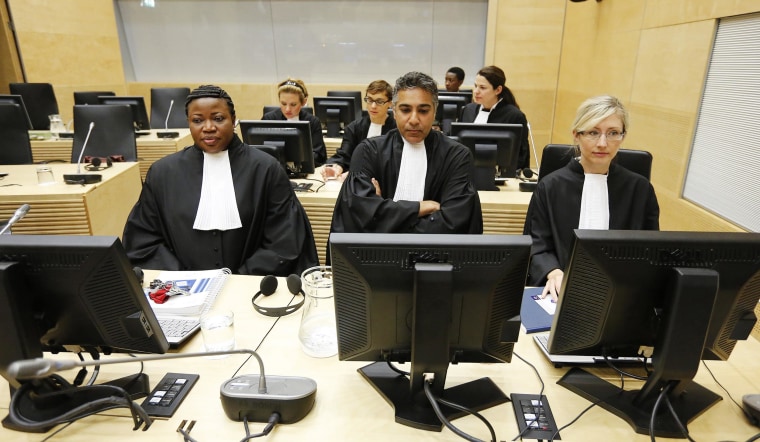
[31,129,193,180]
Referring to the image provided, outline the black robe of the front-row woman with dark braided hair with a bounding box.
[123,136,319,276]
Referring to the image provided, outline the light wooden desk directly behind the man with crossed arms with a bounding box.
[296,169,533,263]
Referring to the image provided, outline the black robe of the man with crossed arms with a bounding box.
[331,129,483,234]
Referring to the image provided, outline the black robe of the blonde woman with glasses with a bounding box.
[523,160,660,286]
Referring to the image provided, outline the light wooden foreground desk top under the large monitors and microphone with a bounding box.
[0,273,760,442]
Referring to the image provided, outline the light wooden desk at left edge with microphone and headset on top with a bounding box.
[0,163,142,237]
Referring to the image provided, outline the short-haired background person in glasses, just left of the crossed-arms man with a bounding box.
[322,80,396,181]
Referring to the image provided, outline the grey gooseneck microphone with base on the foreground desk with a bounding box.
[6,349,317,423]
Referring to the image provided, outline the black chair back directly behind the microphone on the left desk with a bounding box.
[71,104,137,163]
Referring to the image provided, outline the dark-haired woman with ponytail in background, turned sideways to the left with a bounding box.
[460,66,530,169]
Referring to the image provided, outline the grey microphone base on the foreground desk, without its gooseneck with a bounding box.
[221,374,317,424]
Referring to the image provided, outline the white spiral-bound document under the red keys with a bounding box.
[146,269,230,316]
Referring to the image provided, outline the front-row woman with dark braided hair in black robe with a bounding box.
[122,85,318,276]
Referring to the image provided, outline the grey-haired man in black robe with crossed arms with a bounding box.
[331,72,483,234]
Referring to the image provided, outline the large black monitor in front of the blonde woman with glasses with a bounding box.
[549,230,760,437]
